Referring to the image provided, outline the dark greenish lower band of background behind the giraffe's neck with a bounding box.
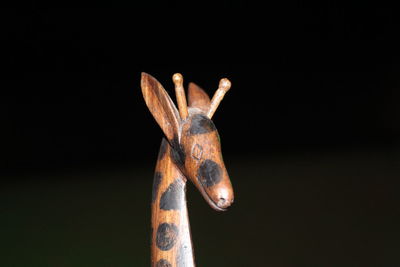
[0,151,400,267]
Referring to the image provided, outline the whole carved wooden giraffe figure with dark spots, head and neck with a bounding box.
[141,73,233,267]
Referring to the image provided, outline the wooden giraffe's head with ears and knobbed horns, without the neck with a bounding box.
[141,73,233,211]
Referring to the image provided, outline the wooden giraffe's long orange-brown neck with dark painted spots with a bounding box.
[151,139,194,267]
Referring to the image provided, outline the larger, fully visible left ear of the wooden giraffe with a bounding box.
[141,72,181,140]
